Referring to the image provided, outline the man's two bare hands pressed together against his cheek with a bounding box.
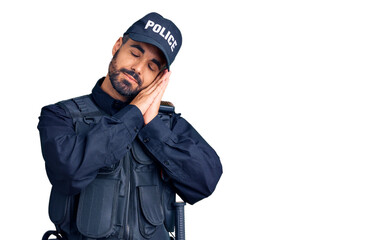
[130,70,171,124]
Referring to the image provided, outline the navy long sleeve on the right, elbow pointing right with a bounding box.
[138,115,222,204]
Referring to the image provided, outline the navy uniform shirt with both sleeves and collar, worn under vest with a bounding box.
[38,78,222,204]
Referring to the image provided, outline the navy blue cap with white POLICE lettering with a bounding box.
[124,12,182,69]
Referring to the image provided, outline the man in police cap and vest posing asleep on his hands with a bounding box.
[38,13,222,239]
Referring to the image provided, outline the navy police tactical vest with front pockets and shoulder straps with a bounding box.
[49,95,175,240]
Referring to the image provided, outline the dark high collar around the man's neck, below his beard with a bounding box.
[91,77,129,115]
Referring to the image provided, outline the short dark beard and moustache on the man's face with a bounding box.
[109,51,142,99]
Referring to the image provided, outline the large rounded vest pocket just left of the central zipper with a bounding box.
[77,177,120,238]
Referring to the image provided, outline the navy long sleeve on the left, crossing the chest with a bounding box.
[38,105,144,195]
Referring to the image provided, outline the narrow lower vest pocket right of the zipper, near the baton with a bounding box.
[138,186,164,238]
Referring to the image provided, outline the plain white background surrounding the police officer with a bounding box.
[0,0,391,240]
